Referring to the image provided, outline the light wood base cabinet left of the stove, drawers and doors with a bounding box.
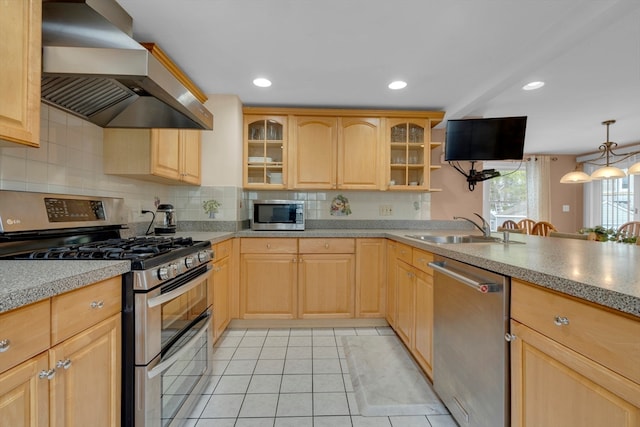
[0,277,122,427]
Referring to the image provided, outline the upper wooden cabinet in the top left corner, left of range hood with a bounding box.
[0,0,42,147]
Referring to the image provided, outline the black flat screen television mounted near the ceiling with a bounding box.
[444,116,527,161]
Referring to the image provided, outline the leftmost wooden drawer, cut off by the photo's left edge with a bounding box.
[0,299,51,372]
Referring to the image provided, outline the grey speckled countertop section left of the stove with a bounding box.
[0,260,131,313]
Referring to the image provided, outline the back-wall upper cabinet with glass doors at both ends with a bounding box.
[244,107,444,191]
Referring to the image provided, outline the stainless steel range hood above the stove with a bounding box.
[42,0,213,129]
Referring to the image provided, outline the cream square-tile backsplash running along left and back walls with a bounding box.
[0,104,431,229]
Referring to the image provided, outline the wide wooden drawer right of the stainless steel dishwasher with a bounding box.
[511,280,640,383]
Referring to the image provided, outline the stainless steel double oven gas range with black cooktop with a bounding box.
[0,191,213,427]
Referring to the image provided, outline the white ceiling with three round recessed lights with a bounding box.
[118,0,640,154]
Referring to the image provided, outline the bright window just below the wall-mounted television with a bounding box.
[483,162,527,231]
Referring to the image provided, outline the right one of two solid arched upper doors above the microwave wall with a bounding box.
[338,117,384,190]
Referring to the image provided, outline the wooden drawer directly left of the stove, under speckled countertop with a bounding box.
[51,276,122,345]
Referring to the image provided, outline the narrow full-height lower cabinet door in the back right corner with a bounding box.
[356,239,386,317]
